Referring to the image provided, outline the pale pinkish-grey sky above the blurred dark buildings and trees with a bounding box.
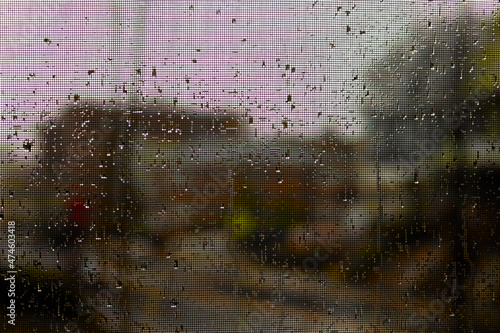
[0,0,496,161]
